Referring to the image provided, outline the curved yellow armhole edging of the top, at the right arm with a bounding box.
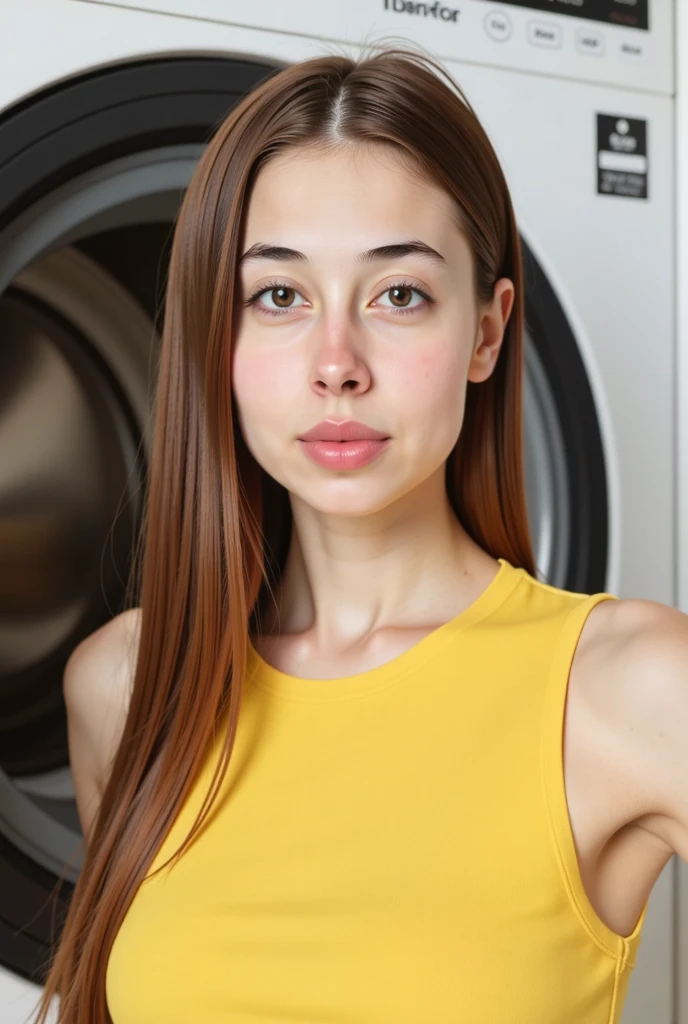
[541,593,647,967]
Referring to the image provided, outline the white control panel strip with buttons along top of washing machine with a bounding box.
[83,0,675,94]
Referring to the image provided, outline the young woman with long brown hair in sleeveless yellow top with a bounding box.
[30,39,688,1024]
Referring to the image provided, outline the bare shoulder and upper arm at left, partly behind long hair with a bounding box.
[62,608,140,833]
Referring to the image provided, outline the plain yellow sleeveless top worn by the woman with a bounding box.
[106,559,647,1024]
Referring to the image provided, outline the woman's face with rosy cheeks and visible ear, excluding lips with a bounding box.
[231,145,513,515]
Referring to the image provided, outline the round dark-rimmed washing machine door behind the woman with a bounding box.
[0,58,608,987]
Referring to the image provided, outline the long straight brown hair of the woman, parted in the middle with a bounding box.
[36,36,534,1024]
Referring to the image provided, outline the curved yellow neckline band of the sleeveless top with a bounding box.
[246,558,522,702]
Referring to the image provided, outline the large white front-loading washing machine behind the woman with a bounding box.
[0,0,675,1024]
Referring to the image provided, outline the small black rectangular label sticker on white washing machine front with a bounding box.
[597,114,647,199]
